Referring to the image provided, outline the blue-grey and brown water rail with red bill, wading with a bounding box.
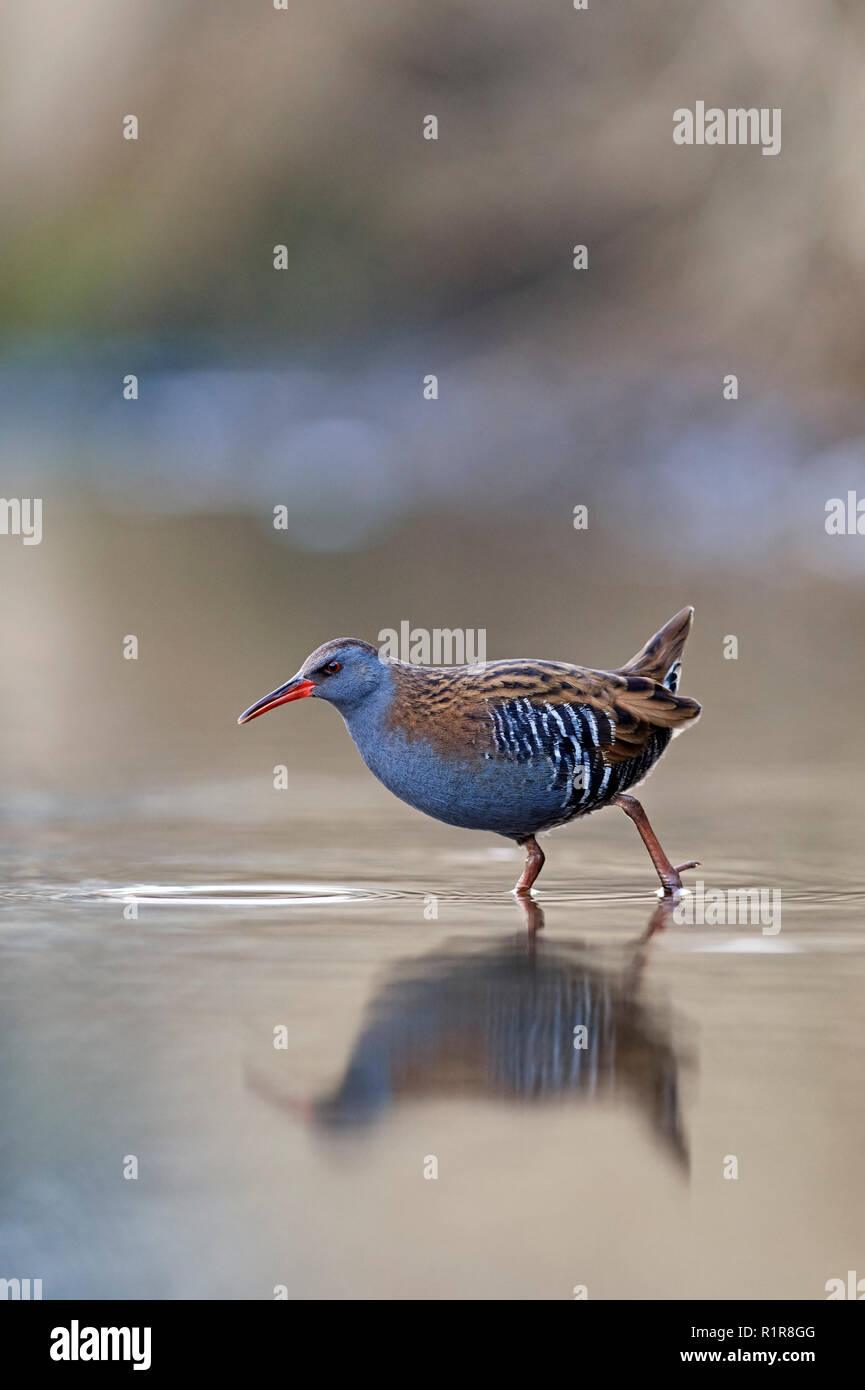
[238,607,701,898]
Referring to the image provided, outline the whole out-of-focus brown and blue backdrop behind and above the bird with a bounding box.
[0,0,865,794]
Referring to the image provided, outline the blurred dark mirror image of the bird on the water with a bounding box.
[252,901,688,1169]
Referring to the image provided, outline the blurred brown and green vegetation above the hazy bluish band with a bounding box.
[0,0,865,384]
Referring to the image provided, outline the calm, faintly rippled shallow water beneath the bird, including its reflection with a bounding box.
[0,765,865,1298]
